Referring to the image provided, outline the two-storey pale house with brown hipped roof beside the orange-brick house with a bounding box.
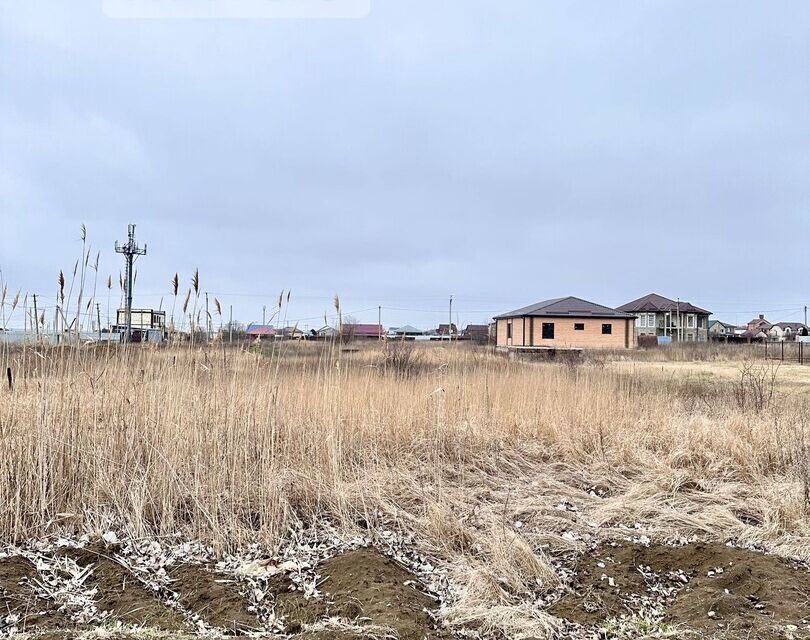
[617,293,711,342]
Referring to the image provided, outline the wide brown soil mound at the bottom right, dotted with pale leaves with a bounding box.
[550,544,810,640]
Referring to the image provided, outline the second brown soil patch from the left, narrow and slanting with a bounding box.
[65,545,187,631]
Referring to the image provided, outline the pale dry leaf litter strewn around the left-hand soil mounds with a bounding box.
[0,522,460,636]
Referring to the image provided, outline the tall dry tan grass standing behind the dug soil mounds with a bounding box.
[0,343,810,635]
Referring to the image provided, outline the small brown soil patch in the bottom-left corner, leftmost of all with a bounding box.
[0,556,66,632]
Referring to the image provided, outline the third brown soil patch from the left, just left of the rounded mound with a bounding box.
[169,564,261,633]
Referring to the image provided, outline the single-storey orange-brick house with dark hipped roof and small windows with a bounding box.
[495,296,635,350]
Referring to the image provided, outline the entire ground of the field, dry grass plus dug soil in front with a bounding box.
[0,343,810,640]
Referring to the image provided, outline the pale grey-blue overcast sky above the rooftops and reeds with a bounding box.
[0,0,810,327]
